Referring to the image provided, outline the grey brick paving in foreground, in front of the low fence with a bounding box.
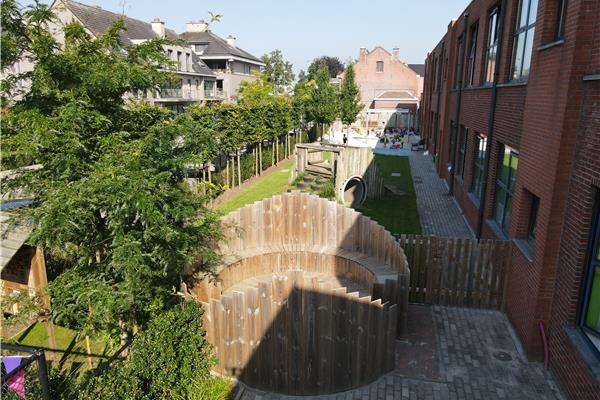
[236,305,563,400]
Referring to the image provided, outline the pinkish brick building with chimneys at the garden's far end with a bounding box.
[354,47,424,129]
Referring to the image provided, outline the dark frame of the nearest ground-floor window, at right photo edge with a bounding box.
[577,189,600,358]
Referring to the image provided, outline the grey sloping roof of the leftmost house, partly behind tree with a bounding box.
[56,0,215,76]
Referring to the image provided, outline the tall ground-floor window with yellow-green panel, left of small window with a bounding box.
[494,145,519,236]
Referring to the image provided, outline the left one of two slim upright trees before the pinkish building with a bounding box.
[310,64,339,138]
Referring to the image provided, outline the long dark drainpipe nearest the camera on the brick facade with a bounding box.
[475,0,506,239]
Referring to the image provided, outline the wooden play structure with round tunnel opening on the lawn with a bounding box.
[292,143,384,206]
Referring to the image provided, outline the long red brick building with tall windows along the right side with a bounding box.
[421,0,600,399]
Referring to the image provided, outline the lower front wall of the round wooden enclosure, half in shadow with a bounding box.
[203,271,398,395]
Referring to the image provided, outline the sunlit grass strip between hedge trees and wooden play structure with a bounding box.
[216,160,292,214]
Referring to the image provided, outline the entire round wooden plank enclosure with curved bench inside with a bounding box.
[193,192,409,395]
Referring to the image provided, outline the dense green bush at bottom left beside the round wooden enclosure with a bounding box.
[80,302,215,400]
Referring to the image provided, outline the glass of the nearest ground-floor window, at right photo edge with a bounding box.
[580,191,600,350]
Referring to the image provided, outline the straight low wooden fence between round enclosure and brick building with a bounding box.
[398,235,511,310]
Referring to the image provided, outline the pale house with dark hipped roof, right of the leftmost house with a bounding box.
[180,21,265,102]
